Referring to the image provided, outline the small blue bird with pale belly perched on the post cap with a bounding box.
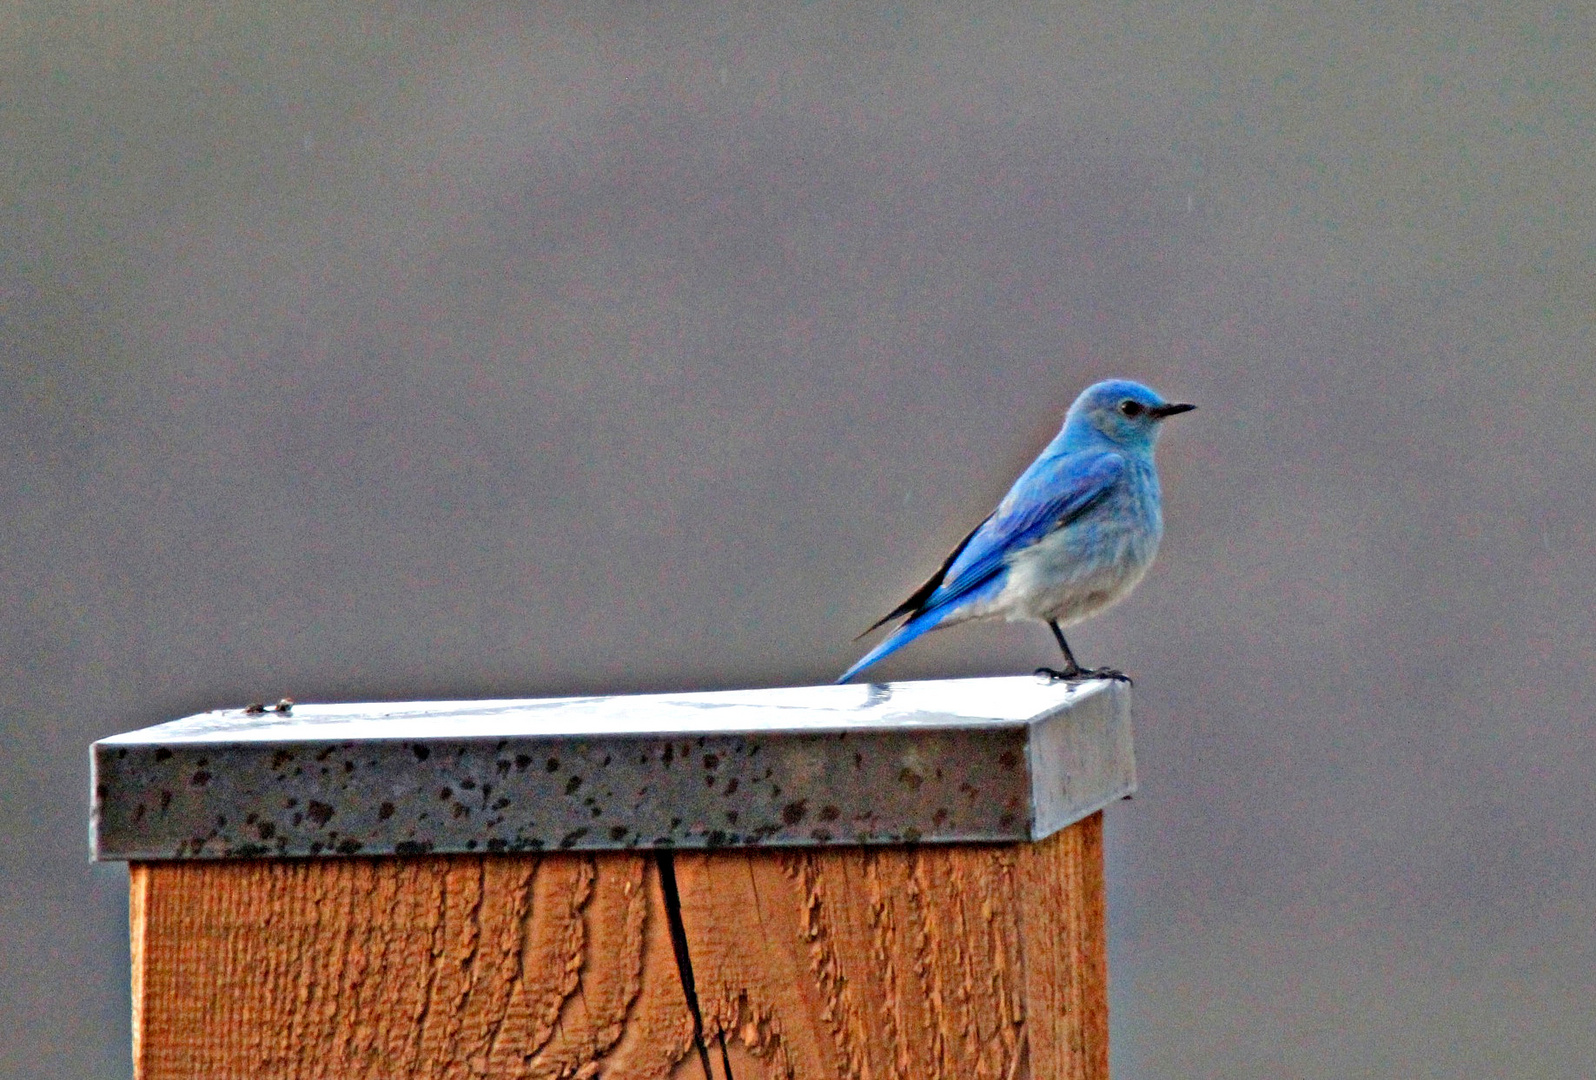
[836,380,1195,683]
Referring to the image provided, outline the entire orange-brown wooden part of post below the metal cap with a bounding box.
[131,815,1108,1080]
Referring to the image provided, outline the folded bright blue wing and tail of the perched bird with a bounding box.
[838,451,1125,683]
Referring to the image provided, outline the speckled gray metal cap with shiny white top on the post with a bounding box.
[91,676,1136,860]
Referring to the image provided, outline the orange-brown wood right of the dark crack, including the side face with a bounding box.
[677,815,1108,1080]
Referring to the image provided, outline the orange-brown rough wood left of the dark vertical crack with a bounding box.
[131,855,693,1080]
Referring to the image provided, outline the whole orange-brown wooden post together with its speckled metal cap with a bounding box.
[94,680,1135,1080]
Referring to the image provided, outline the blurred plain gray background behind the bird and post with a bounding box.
[0,0,1596,1080]
